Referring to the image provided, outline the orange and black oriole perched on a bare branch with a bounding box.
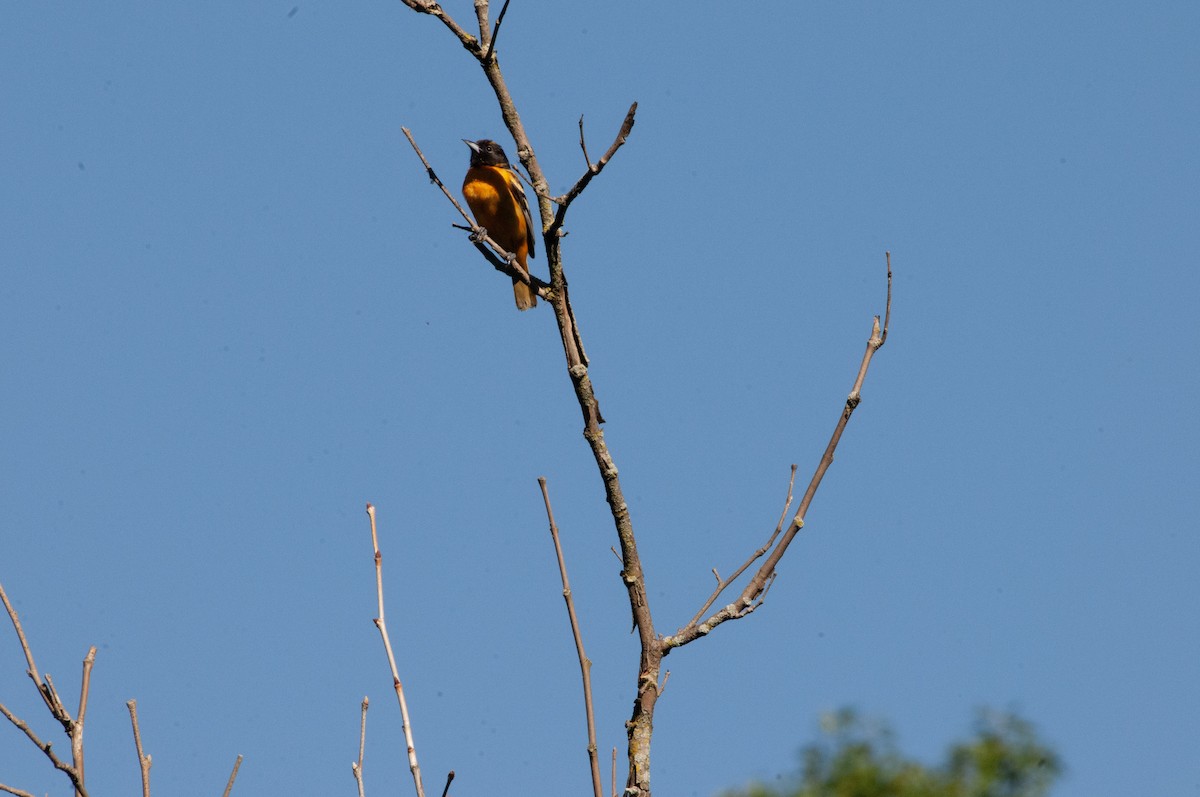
[462,138,538,310]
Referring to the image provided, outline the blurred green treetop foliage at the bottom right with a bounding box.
[724,708,1062,797]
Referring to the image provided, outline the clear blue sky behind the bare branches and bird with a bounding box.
[0,0,1200,797]
